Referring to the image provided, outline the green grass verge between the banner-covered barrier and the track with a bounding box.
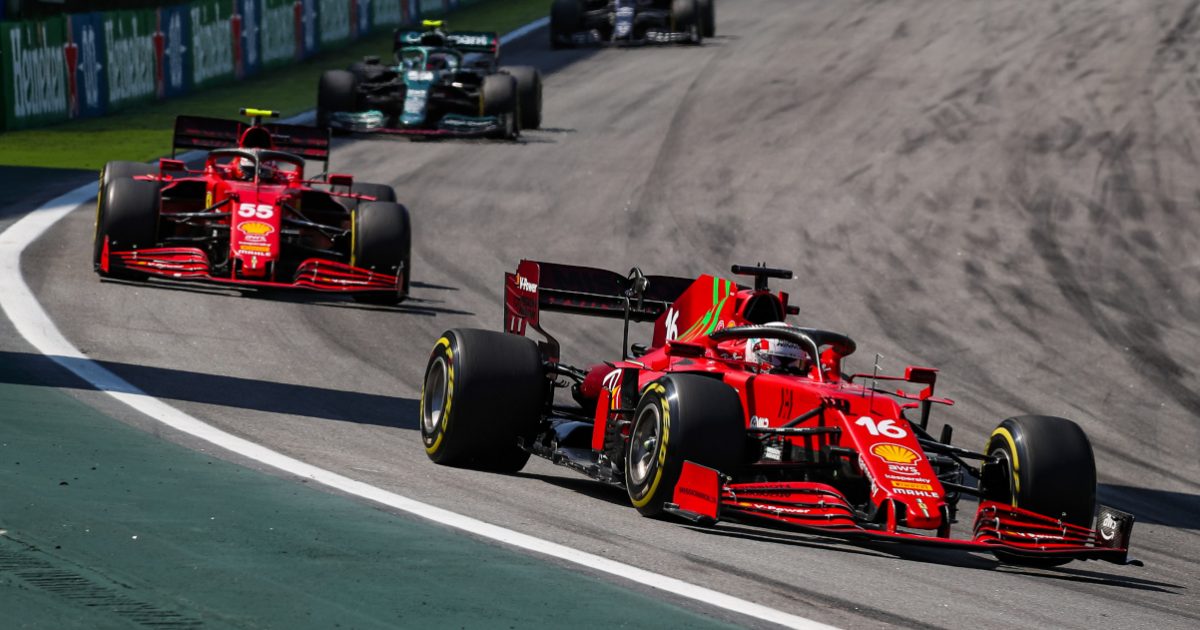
[0,0,550,170]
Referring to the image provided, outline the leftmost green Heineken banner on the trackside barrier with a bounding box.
[0,18,67,130]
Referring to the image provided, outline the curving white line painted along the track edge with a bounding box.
[0,20,833,630]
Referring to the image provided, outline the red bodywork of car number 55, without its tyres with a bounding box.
[98,116,407,293]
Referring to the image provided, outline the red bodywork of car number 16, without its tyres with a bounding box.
[505,260,1132,563]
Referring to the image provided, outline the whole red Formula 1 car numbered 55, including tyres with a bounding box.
[94,109,412,304]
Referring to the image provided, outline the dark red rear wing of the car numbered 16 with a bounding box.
[504,260,695,337]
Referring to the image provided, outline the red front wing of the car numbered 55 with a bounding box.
[100,239,398,293]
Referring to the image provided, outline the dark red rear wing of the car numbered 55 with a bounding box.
[170,116,330,164]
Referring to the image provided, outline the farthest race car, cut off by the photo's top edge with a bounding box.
[550,0,716,48]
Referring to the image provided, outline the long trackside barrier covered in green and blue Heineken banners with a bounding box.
[0,0,424,130]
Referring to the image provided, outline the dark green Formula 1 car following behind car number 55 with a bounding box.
[317,20,541,138]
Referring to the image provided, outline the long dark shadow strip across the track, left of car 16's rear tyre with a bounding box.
[0,352,419,430]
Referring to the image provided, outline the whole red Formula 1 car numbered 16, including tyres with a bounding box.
[420,260,1133,566]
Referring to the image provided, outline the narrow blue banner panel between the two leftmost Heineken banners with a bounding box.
[62,13,108,118]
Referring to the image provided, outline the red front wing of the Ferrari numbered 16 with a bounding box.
[666,462,1140,564]
